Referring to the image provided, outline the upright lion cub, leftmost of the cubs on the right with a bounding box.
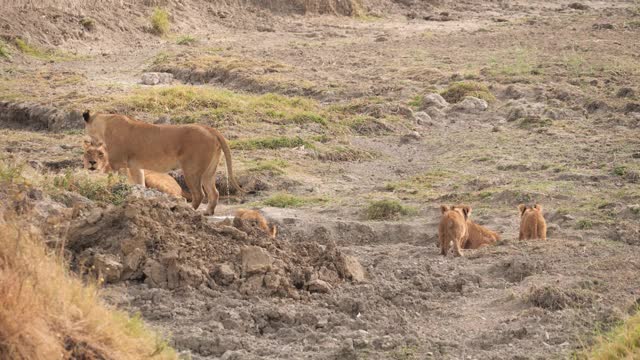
[438,205,471,256]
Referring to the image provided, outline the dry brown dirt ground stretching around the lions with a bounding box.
[0,0,640,359]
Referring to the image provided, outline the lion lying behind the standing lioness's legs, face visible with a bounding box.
[82,141,189,199]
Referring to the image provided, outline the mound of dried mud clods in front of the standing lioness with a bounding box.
[68,189,365,298]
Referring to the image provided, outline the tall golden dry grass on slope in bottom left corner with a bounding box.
[0,195,177,360]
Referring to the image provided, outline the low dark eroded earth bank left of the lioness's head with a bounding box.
[0,102,84,131]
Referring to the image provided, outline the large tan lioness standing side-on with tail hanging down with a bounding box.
[82,110,242,215]
